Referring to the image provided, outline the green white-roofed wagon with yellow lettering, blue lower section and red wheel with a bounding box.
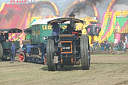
[19,18,60,64]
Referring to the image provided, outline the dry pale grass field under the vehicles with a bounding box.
[0,54,128,85]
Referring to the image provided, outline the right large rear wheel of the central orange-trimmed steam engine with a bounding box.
[80,35,90,70]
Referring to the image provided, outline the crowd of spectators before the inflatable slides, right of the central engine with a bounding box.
[90,40,128,51]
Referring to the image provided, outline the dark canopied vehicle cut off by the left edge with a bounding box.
[0,28,22,60]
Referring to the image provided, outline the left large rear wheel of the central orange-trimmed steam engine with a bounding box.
[46,39,56,71]
